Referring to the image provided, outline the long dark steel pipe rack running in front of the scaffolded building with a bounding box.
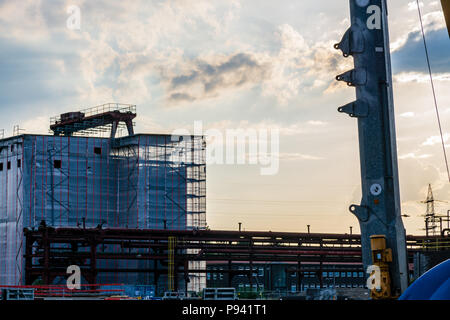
[24,223,450,290]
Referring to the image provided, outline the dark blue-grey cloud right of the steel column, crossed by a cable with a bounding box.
[392,29,450,73]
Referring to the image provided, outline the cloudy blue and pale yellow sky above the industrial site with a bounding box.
[0,0,450,235]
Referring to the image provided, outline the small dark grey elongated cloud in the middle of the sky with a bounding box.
[167,53,269,101]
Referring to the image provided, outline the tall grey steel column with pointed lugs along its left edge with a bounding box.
[335,0,408,296]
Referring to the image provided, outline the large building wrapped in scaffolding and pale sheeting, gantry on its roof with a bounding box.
[0,104,206,290]
